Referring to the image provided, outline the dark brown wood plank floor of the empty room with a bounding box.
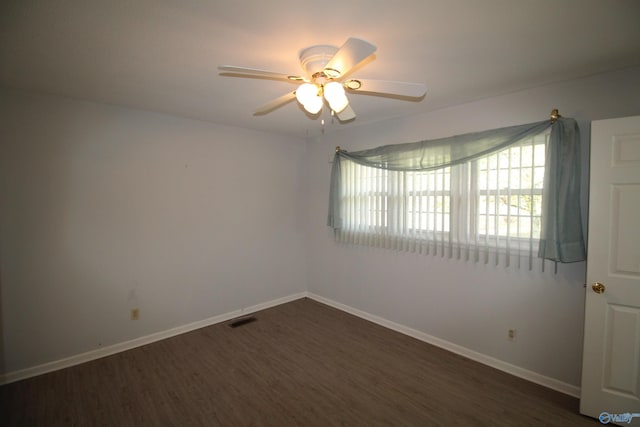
[0,299,600,427]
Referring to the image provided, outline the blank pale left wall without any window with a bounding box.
[0,92,306,372]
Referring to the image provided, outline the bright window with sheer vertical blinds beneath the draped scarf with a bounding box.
[339,133,548,256]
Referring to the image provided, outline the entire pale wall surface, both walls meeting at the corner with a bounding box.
[0,68,640,386]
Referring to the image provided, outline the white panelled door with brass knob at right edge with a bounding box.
[580,116,640,425]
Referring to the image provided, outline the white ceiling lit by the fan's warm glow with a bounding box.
[0,0,640,137]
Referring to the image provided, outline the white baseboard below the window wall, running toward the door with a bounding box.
[307,292,580,398]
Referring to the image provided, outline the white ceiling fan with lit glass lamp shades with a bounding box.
[218,37,426,122]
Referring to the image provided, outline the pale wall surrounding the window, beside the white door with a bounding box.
[306,68,640,386]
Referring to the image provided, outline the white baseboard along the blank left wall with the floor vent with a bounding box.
[0,292,307,385]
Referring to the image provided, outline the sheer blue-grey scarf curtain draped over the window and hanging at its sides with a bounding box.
[327,117,586,262]
